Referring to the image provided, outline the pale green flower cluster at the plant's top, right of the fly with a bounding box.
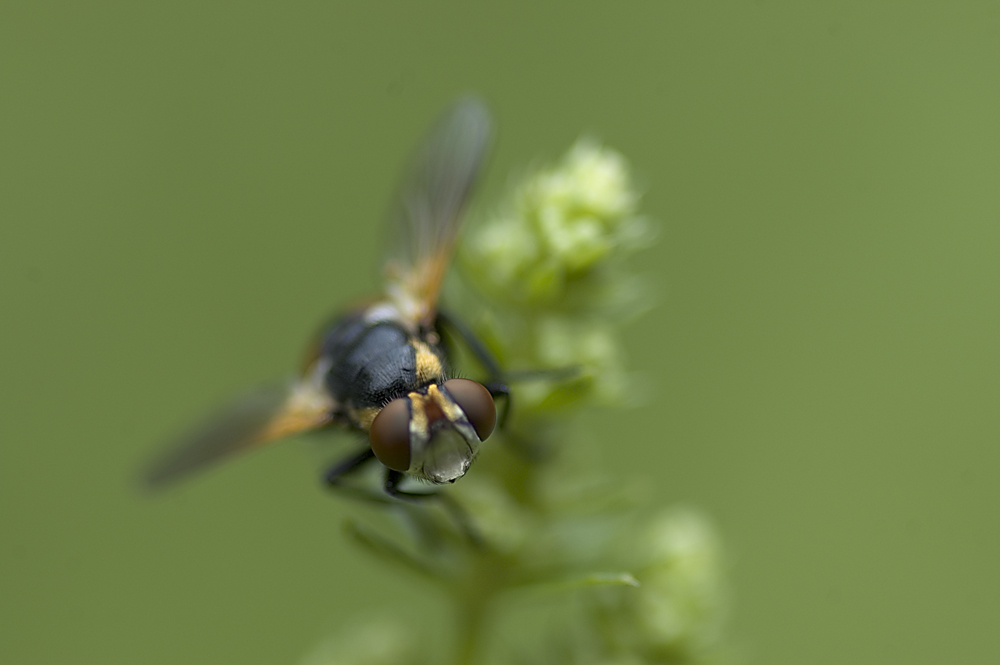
[463,139,653,413]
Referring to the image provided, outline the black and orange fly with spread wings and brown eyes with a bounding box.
[145,99,507,496]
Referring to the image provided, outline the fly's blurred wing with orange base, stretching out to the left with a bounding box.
[143,381,334,489]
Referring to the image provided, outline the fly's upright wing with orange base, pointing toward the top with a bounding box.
[385,98,491,324]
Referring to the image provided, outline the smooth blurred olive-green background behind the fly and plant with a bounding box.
[0,1,1000,665]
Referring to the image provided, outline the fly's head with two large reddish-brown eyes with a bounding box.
[369,379,497,484]
